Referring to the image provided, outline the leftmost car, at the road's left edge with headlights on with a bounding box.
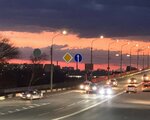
[20,90,43,100]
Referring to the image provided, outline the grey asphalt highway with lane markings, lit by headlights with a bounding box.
[0,73,150,120]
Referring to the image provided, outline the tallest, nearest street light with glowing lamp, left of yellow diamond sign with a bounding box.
[50,30,67,91]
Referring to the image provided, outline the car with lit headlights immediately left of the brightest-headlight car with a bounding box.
[85,83,98,93]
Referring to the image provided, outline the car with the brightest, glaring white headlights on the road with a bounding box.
[98,85,113,95]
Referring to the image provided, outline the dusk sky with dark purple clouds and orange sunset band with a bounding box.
[0,0,150,68]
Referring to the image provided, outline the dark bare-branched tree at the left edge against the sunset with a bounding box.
[0,37,19,63]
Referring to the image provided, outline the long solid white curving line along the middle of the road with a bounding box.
[52,91,124,120]
